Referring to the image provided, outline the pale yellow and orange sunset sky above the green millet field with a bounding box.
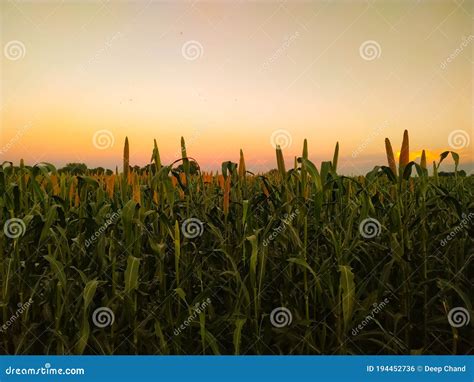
[0,0,474,174]
